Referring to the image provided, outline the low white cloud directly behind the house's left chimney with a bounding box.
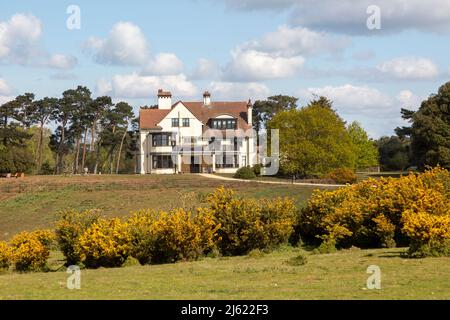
[106,73,197,98]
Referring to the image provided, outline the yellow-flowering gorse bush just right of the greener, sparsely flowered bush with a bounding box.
[75,218,131,268]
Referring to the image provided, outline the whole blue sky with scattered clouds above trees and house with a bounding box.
[0,0,450,138]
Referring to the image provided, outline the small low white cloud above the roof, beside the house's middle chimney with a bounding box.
[209,82,270,100]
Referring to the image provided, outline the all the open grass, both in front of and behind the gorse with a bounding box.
[0,175,450,300]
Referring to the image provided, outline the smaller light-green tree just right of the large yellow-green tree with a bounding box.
[347,121,379,169]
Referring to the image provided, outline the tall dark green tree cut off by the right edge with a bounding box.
[396,82,450,169]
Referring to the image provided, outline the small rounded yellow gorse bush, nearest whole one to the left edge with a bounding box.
[11,231,51,271]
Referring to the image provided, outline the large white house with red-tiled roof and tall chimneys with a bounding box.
[139,89,256,174]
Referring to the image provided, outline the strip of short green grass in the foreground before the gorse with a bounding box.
[0,247,450,300]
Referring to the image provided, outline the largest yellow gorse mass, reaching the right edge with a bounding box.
[296,168,450,255]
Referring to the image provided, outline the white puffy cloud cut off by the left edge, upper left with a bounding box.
[0,13,77,69]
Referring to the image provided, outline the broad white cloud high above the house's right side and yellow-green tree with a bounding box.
[241,25,350,57]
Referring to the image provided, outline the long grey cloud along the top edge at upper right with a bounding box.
[216,0,450,35]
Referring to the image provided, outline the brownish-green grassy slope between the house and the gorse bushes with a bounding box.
[0,175,334,240]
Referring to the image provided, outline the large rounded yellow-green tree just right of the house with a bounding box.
[268,100,356,177]
